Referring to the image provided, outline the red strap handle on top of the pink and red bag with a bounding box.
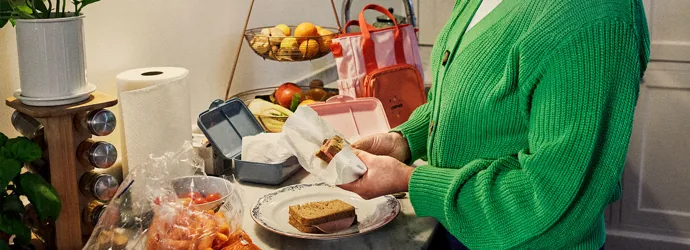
[359,4,406,73]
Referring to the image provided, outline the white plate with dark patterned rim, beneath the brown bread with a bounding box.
[250,183,400,240]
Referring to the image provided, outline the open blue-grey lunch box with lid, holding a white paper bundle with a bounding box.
[197,98,300,185]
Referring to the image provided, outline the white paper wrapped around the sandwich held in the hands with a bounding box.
[282,106,367,185]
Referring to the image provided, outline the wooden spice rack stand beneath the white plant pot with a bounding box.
[6,92,117,249]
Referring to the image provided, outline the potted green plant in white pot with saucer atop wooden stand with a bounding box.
[0,0,99,106]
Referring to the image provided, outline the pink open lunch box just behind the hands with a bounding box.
[309,95,391,139]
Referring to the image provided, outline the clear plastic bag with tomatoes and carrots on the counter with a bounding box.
[84,143,258,250]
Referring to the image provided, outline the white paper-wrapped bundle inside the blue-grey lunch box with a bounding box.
[242,133,292,164]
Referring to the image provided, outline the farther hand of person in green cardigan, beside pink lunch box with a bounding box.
[352,132,410,162]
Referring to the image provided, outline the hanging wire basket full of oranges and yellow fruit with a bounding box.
[244,26,338,62]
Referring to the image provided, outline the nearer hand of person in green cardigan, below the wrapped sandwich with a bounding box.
[339,150,414,200]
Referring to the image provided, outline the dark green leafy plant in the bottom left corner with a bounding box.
[0,133,61,250]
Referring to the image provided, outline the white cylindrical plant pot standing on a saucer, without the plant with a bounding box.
[16,16,87,98]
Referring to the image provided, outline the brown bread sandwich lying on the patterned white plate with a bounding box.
[289,200,356,229]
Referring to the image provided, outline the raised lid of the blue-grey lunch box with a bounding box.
[197,97,264,159]
